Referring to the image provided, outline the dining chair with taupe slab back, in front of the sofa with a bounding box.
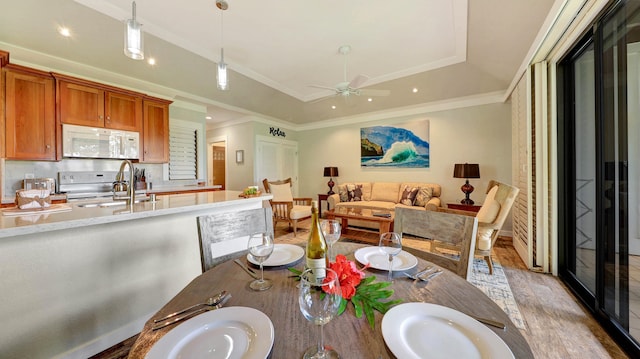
[394,207,478,279]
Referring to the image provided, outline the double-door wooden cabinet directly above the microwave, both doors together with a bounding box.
[53,74,142,132]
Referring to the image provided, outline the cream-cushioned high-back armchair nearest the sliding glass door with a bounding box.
[432,180,520,274]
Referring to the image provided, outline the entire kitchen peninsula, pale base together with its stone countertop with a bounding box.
[0,191,271,358]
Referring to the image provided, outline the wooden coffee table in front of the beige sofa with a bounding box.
[325,207,394,245]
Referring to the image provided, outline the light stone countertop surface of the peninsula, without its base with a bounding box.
[0,191,272,238]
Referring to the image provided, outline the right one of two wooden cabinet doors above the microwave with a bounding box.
[104,92,142,132]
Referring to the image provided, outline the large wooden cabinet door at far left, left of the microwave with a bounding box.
[5,70,56,160]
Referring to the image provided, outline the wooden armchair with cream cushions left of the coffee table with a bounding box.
[262,178,311,237]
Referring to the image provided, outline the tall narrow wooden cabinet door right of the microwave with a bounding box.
[140,100,169,163]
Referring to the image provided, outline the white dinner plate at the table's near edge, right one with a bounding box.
[382,303,514,359]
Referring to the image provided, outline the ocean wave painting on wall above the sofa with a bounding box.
[360,120,430,168]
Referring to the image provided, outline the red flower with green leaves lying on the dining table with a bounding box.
[289,254,402,329]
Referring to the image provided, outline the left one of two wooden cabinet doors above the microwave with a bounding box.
[58,81,104,127]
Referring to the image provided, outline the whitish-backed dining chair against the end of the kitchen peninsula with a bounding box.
[197,207,274,273]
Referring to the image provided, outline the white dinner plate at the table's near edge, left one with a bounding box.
[146,307,274,359]
